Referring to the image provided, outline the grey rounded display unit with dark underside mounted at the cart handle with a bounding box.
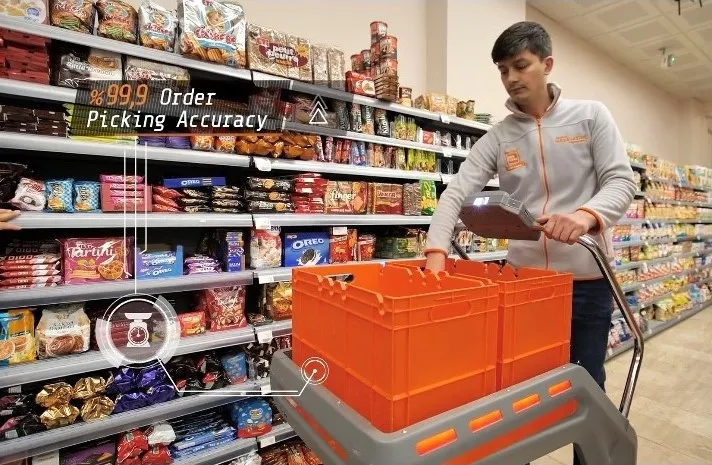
[460,191,541,241]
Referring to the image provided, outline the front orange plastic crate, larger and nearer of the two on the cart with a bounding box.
[292,263,498,432]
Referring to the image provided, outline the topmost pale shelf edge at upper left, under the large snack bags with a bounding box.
[0,16,252,81]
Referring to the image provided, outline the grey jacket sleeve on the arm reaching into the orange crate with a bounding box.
[425,130,499,255]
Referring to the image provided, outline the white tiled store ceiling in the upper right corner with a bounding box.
[527,0,712,111]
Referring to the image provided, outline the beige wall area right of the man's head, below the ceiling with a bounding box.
[526,6,712,166]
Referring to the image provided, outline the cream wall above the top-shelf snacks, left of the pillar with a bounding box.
[136,0,427,95]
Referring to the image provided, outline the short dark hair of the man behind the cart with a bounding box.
[492,21,551,63]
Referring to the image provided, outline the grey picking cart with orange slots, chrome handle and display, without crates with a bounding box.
[270,192,643,465]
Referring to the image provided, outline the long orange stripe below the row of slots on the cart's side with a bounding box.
[442,400,579,465]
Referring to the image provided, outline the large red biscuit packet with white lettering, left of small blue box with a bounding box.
[62,237,134,284]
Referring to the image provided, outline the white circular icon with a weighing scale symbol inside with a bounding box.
[94,294,180,367]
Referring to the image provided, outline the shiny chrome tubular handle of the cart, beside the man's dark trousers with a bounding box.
[452,234,644,418]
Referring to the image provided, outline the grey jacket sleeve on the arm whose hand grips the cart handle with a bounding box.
[579,104,637,233]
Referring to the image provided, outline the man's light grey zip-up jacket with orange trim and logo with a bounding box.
[426,84,637,280]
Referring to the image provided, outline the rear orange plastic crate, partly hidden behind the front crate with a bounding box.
[397,259,573,390]
